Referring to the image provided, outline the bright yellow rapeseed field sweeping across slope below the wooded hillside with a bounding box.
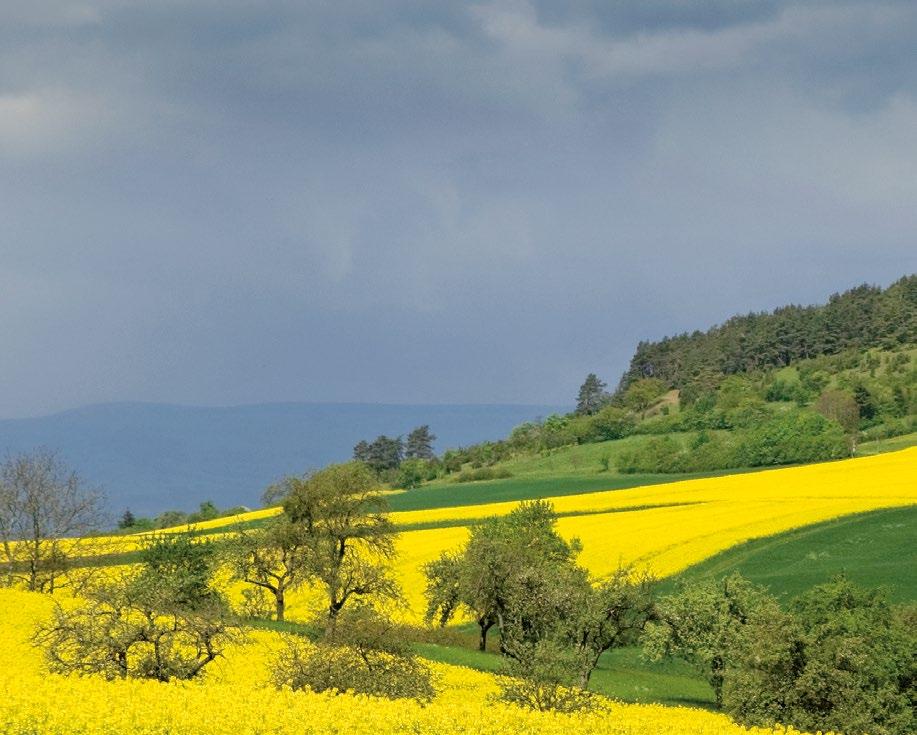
[392,447,917,614]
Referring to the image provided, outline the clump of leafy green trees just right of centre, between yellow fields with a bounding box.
[425,501,655,710]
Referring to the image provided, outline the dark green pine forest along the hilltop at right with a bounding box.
[618,275,917,392]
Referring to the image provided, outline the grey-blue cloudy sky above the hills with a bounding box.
[0,0,917,418]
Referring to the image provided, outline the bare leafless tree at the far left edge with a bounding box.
[0,449,103,593]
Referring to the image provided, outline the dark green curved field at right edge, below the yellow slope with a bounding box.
[666,506,917,602]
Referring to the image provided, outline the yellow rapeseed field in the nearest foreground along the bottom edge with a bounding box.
[0,589,832,735]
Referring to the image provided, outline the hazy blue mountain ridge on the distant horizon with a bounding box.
[0,403,570,515]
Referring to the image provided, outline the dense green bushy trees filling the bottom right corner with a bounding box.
[724,578,917,735]
